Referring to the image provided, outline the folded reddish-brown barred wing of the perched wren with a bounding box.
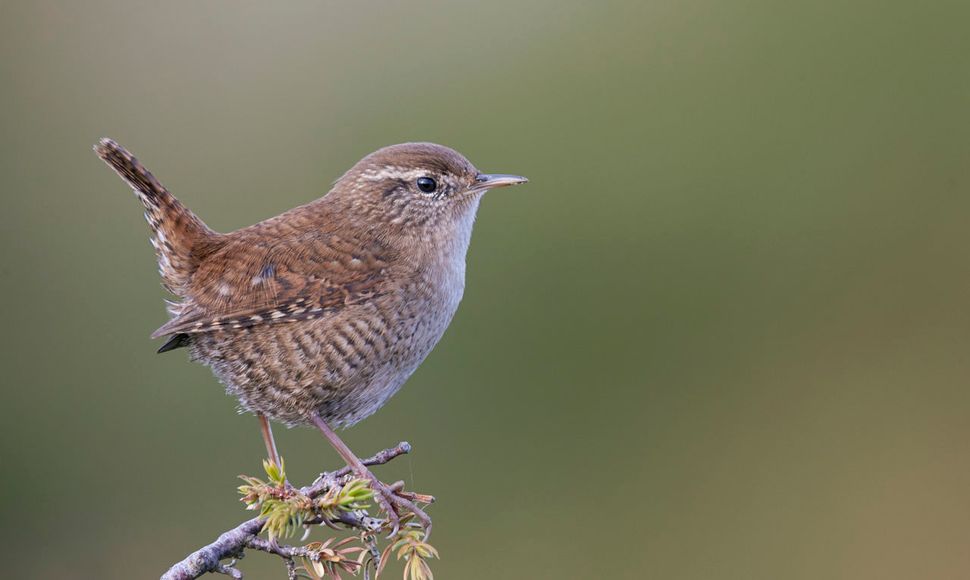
[152,232,392,337]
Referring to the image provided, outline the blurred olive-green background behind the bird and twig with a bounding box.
[0,0,970,579]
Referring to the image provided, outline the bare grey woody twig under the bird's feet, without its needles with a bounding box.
[161,441,411,580]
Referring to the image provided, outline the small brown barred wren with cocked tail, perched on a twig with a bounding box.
[95,139,527,530]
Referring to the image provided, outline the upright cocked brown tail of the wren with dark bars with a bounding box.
[94,139,219,296]
